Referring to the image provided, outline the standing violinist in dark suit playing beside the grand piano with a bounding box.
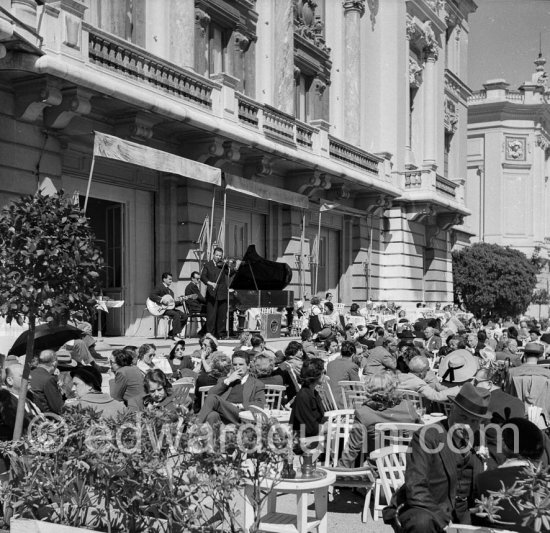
[201,247,238,339]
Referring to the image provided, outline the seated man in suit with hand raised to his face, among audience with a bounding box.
[197,352,265,426]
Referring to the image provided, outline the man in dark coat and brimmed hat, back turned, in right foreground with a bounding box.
[384,383,491,533]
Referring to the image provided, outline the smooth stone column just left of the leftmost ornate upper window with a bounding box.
[168,0,195,70]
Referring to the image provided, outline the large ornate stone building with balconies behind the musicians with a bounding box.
[0,0,476,333]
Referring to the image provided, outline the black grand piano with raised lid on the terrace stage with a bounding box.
[229,244,294,312]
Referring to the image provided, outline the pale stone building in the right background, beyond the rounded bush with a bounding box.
[465,57,550,257]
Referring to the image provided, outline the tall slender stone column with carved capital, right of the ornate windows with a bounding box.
[343,0,365,145]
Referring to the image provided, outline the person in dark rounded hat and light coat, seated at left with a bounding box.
[71,366,124,417]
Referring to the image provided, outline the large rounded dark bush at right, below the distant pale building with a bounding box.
[453,243,538,318]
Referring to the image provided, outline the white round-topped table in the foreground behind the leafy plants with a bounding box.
[244,467,336,533]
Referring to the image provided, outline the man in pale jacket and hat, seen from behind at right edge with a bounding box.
[505,342,550,422]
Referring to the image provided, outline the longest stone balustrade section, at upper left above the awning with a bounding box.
[86,26,216,109]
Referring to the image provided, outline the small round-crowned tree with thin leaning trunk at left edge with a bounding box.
[0,191,103,440]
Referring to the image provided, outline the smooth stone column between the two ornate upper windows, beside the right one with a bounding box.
[273,0,295,115]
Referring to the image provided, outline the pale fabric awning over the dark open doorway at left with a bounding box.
[94,131,222,186]
